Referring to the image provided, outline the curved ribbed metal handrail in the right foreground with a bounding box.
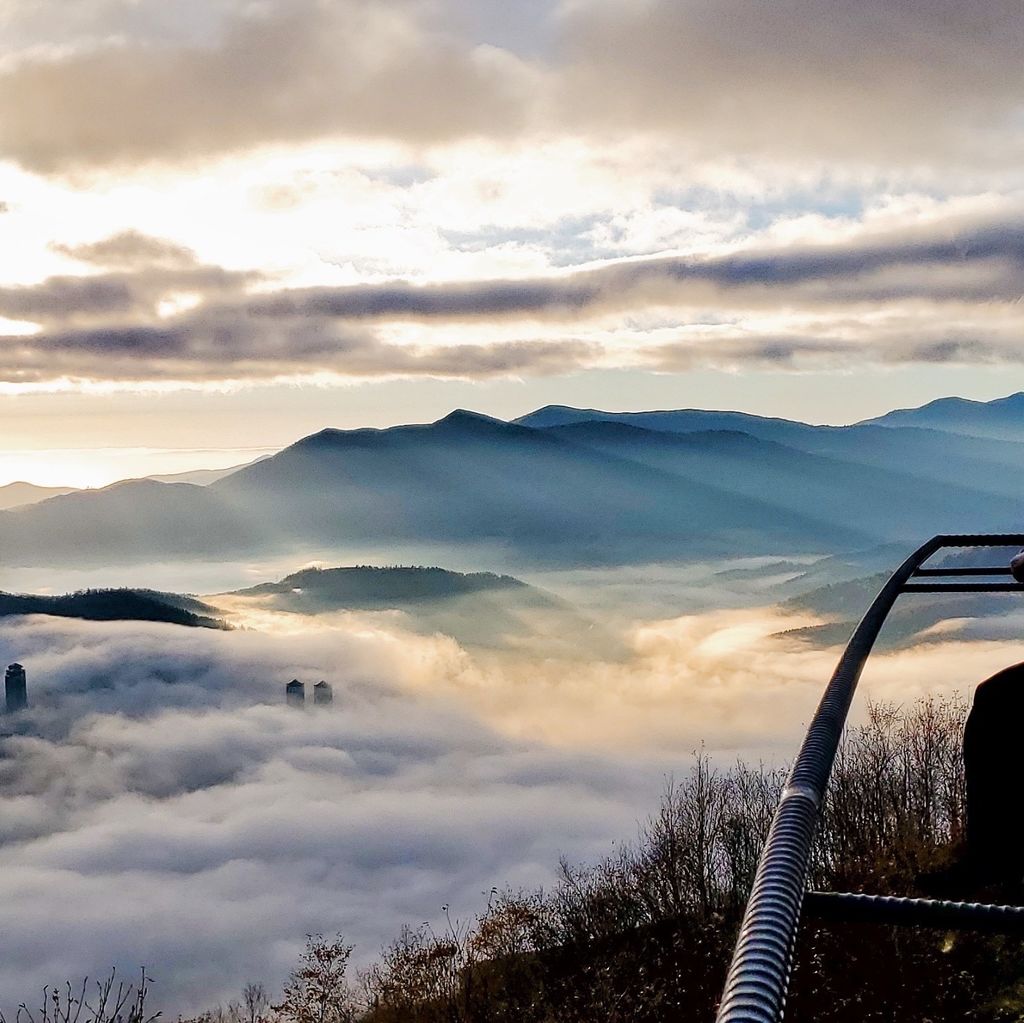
[716,534,1024,1023]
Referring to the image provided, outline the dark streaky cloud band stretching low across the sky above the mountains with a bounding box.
[6,204,1024,384]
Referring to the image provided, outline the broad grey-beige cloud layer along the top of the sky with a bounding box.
[0,0,1024,171]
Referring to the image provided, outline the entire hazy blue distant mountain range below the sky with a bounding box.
[0,395,1024,565]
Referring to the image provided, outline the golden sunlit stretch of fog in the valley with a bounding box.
[205,598,1024,761]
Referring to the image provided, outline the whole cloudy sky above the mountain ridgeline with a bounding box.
[0,0,1024,485]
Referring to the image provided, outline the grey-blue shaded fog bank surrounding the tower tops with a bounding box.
[0,619,660,1012]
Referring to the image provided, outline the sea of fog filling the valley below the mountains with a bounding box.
[0,564,1020,1014]
